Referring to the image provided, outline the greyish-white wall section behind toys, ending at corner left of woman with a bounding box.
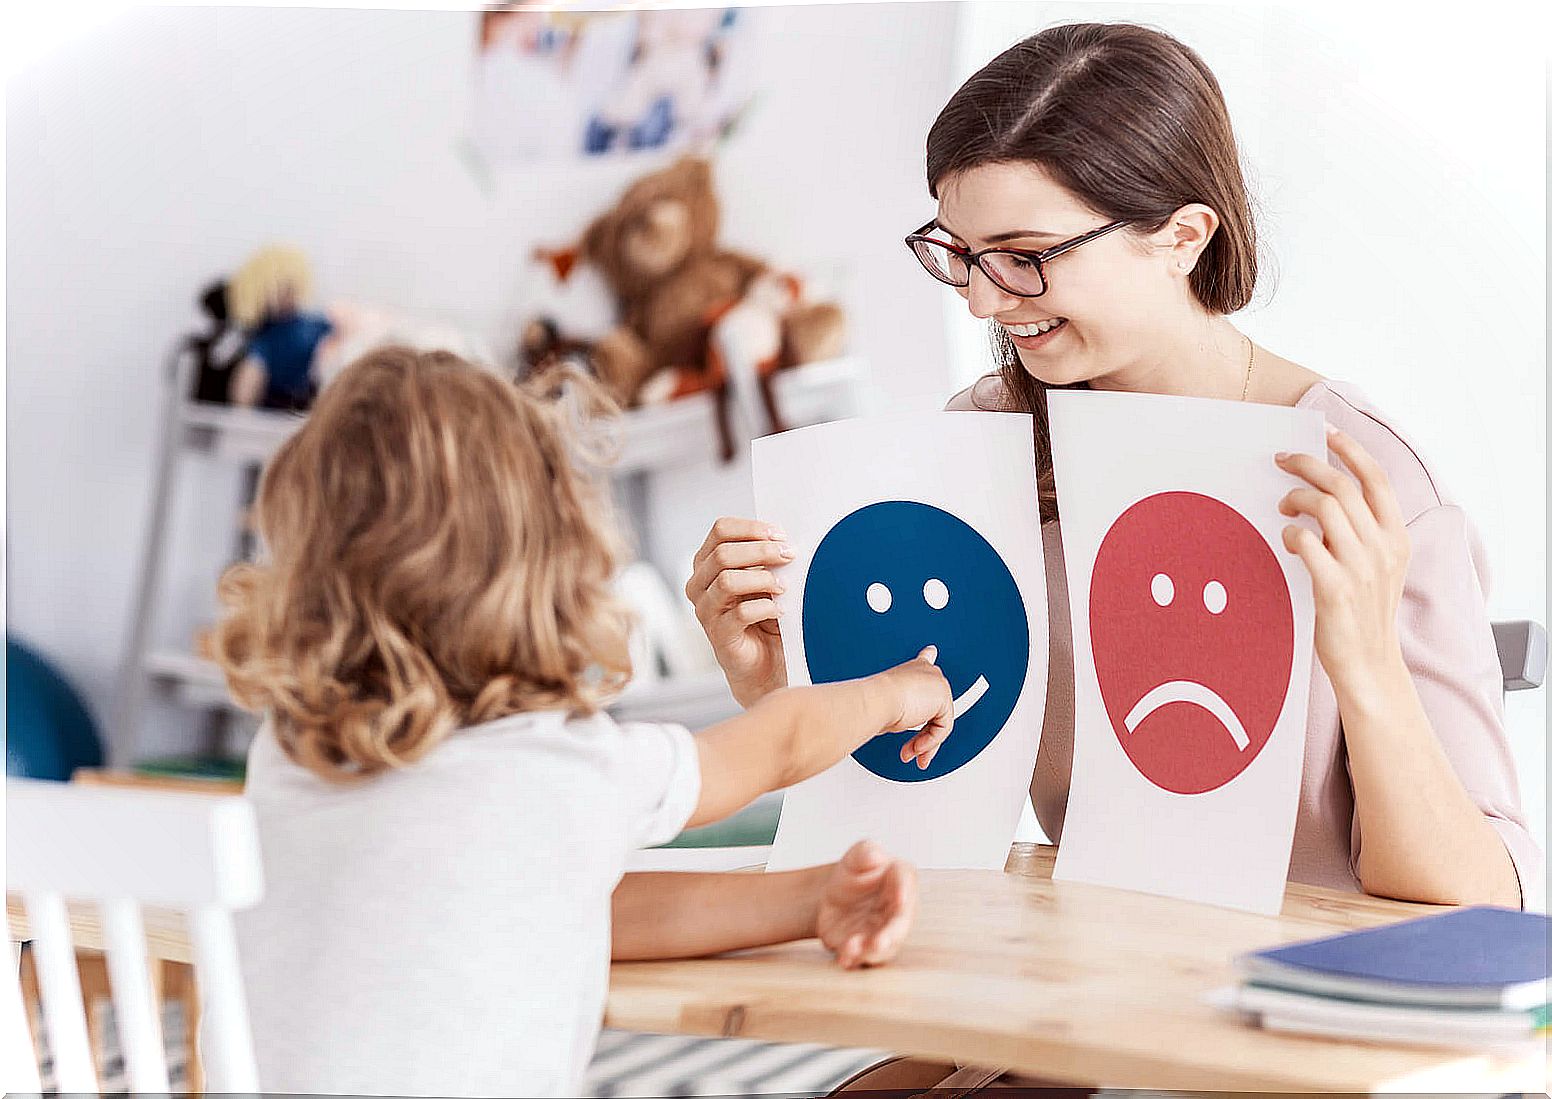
[6,3,954,747]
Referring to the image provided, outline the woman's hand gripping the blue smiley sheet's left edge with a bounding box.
[684,517,793,709]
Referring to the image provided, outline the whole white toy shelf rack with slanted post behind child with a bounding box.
[109,357,864,768]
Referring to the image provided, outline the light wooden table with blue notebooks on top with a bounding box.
[8,844,1549,1093]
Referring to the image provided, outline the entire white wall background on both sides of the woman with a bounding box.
[6,3,1547,894]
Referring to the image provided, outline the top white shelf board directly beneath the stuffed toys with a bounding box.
[178,357,863,475]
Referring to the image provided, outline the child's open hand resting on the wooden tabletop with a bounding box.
[815,840,916,969]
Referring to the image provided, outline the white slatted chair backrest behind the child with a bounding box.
[0,779,264,1093]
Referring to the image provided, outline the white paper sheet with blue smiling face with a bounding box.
[753,411,1048,869]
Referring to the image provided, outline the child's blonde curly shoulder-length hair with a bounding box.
[203,348,630,781]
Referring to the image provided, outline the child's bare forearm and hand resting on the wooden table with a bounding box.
[615,841,916,969]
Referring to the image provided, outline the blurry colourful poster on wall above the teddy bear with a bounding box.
[472,5,753,166]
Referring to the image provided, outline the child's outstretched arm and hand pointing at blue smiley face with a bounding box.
[689,646,954,827]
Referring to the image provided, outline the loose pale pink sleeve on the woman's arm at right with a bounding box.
[1352,504,1546,908]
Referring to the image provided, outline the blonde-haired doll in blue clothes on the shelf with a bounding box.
[227,245,335,410]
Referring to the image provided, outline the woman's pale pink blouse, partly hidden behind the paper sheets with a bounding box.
[948,374,1546,903]
